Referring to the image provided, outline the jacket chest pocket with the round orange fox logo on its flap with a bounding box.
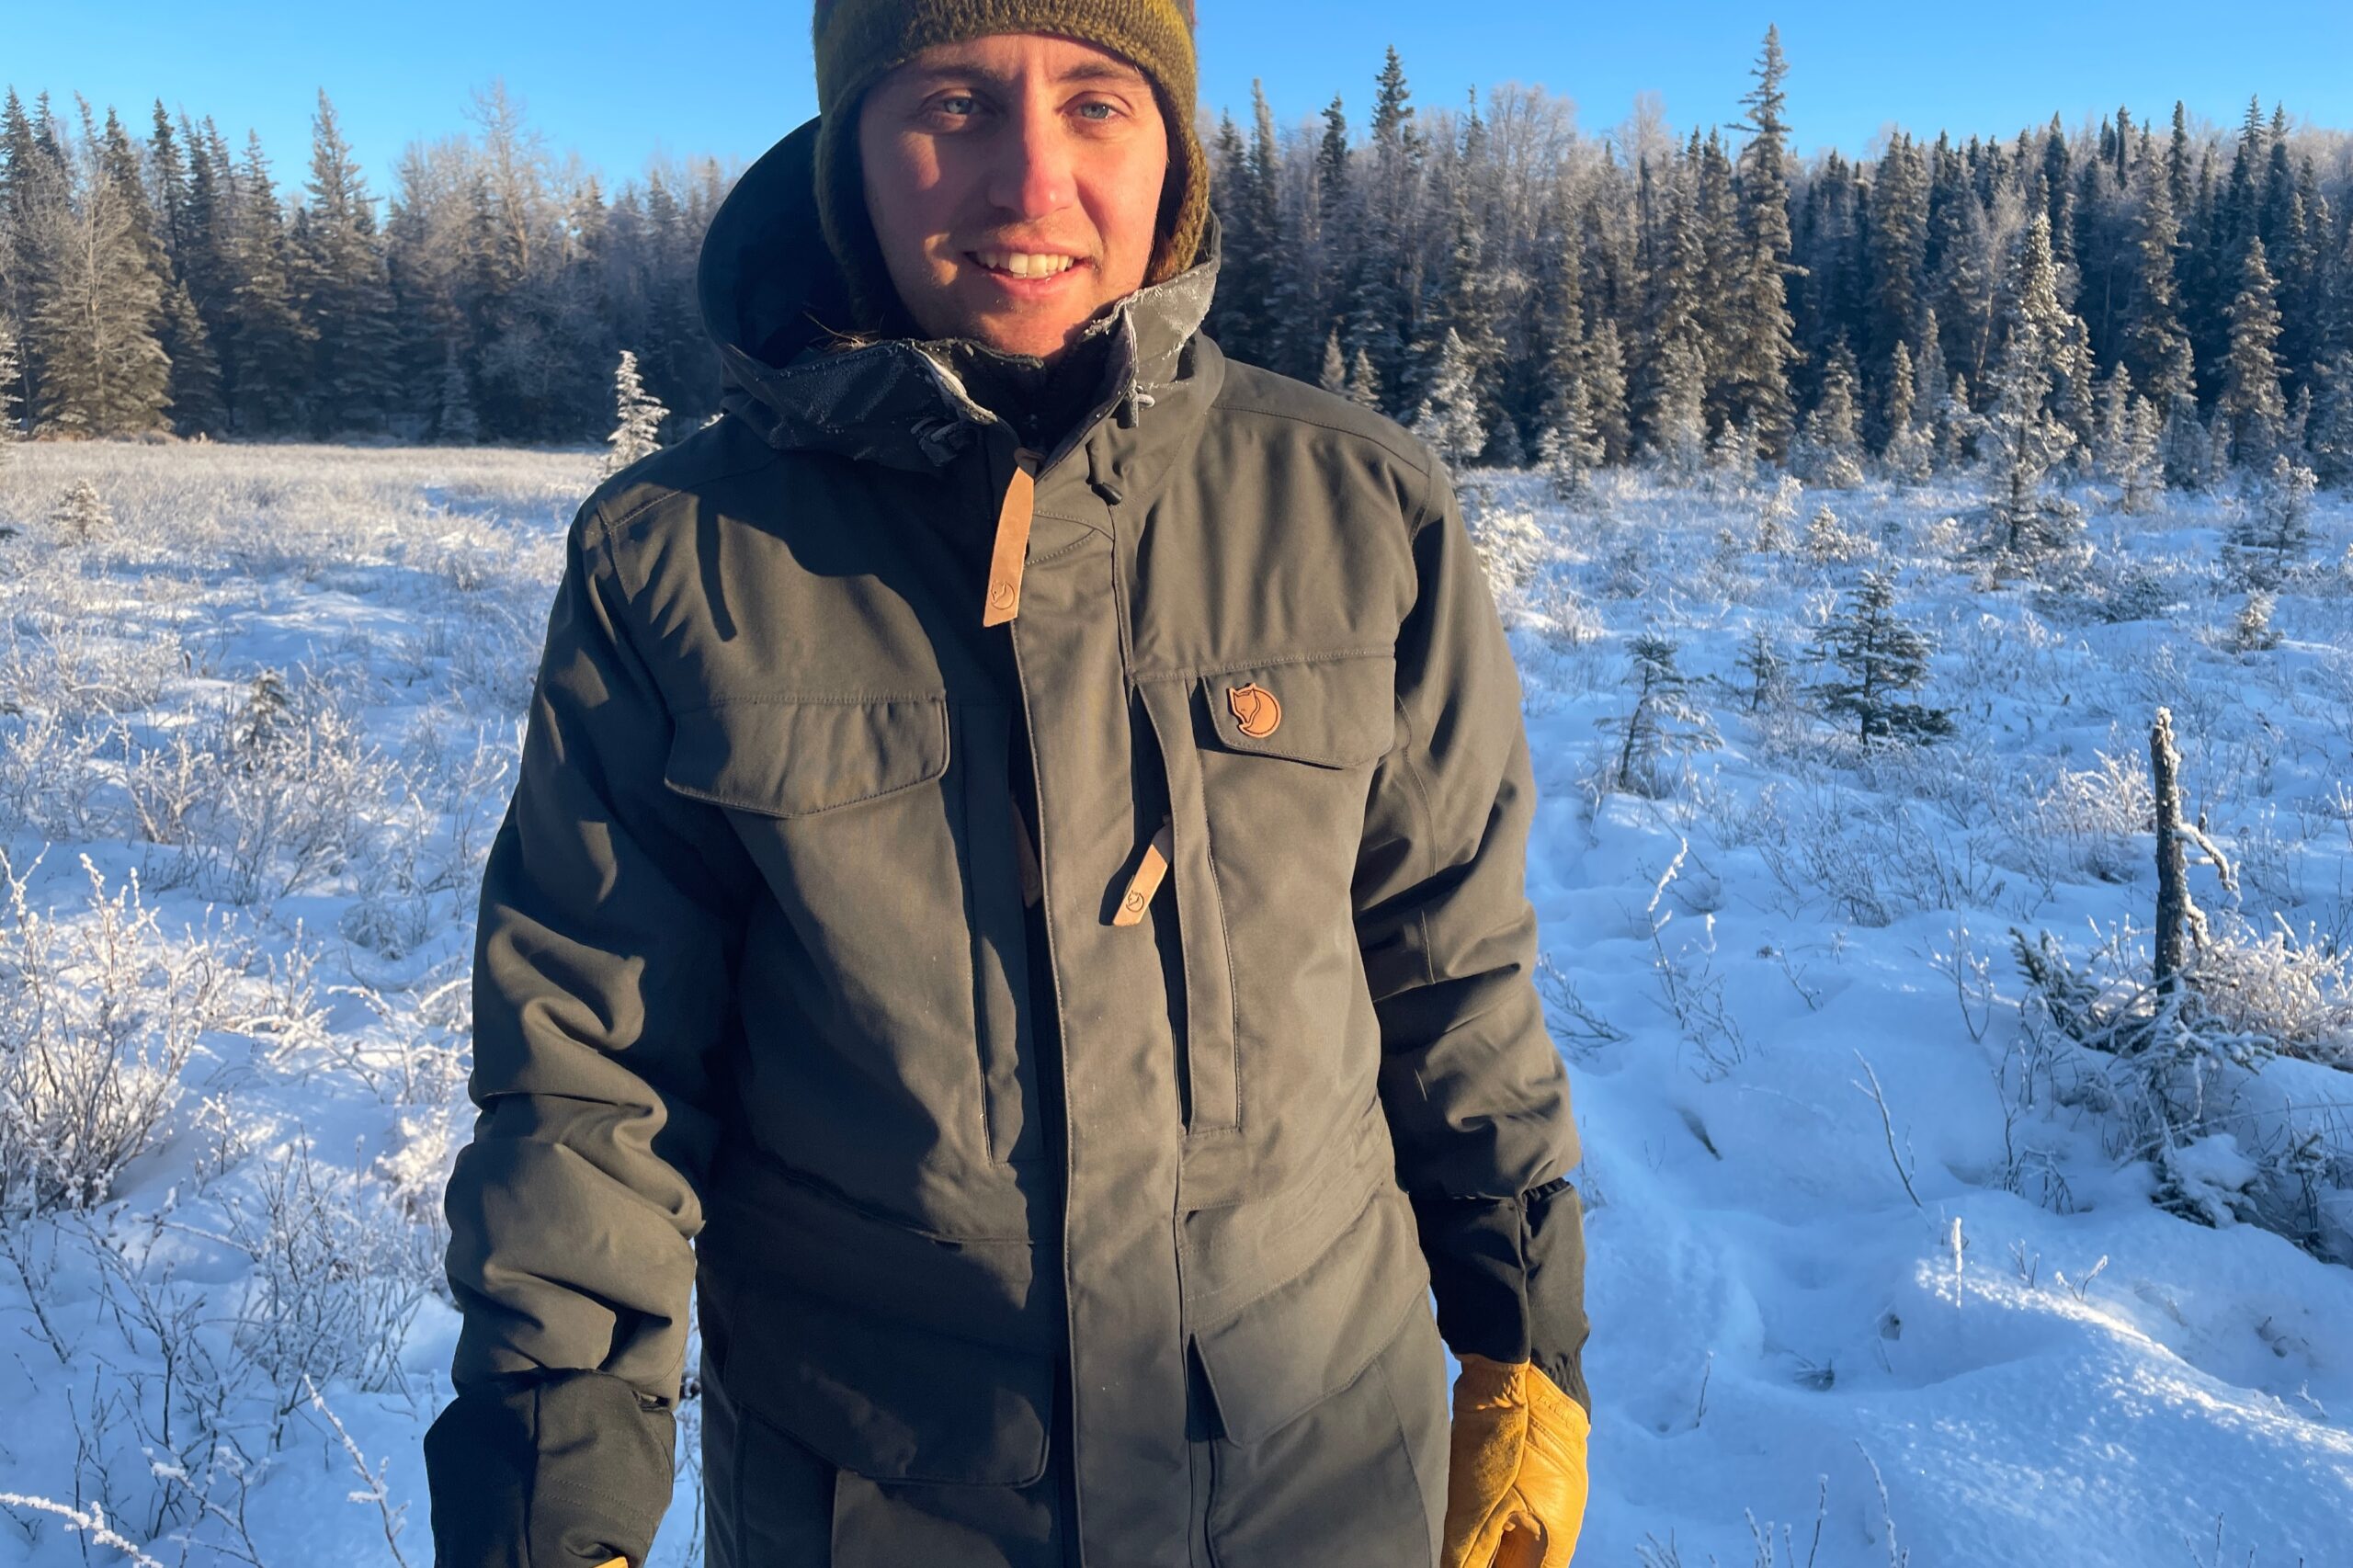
[1139,647,1395,1135]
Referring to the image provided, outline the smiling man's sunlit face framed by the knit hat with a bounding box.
[858,33,1169,358]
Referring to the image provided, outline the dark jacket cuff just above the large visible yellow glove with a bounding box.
[1415,1177,1593,1417]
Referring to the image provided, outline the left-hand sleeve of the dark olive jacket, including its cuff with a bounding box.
[426,496,741,1568]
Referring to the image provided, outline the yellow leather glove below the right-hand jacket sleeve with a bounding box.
[1442,1356,1591,1568]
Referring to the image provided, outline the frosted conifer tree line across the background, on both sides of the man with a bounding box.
[0,33,2353,489]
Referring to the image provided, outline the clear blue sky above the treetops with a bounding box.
[0,0,2353,196]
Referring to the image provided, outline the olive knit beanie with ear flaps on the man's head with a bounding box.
[812,0,1210,318]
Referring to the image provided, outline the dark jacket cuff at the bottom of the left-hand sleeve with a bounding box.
[424,1370,677,1568]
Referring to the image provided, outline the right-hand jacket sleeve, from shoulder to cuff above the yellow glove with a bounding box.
[1353,460,1588,1405]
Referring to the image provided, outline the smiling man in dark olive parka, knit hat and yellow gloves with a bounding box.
[426,0,1586,1568]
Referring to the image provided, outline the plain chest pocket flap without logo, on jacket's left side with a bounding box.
[661,697,949,817]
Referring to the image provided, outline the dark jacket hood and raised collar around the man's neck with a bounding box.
[694,120,1219,471]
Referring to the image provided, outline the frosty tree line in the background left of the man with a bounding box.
[0,85,732,443]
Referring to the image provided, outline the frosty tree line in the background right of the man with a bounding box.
[1211,30,2353,485]
